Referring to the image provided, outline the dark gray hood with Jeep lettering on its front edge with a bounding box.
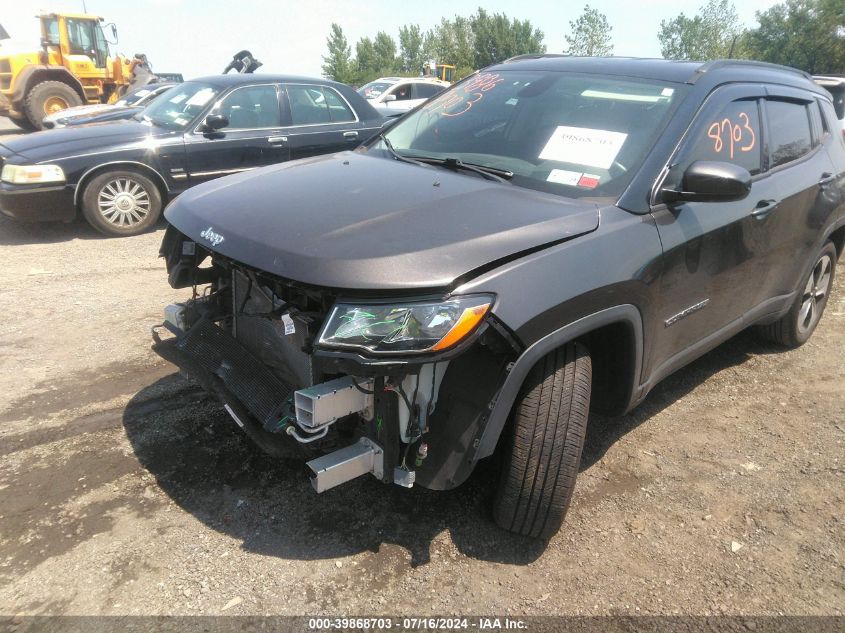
[165,152,599,290]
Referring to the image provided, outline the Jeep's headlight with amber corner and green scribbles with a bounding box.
[318,295,493,354]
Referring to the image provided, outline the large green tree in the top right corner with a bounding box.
[745,0,845,74]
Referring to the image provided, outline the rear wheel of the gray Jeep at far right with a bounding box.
[758,242,836,347]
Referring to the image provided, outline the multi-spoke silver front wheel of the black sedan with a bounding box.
[82,171,161,236]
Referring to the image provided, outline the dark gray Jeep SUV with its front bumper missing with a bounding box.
[154,55,845,538]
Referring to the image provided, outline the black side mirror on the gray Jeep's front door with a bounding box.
[661,160,751,204]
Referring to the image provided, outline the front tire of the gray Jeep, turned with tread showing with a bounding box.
[493,343,592,539]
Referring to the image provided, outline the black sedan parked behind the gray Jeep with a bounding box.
[0,75,384,235]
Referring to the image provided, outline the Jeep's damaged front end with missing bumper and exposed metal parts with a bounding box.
[154,226,520,492]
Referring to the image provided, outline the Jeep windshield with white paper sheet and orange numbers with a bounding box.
[380,70,685,198]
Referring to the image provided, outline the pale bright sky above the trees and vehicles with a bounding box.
[0,0,777,79]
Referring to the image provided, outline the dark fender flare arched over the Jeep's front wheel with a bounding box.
[470,304,643,462]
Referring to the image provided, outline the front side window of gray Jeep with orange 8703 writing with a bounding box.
[670,99,762,178]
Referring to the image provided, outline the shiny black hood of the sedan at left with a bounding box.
[3,120,174,162]
